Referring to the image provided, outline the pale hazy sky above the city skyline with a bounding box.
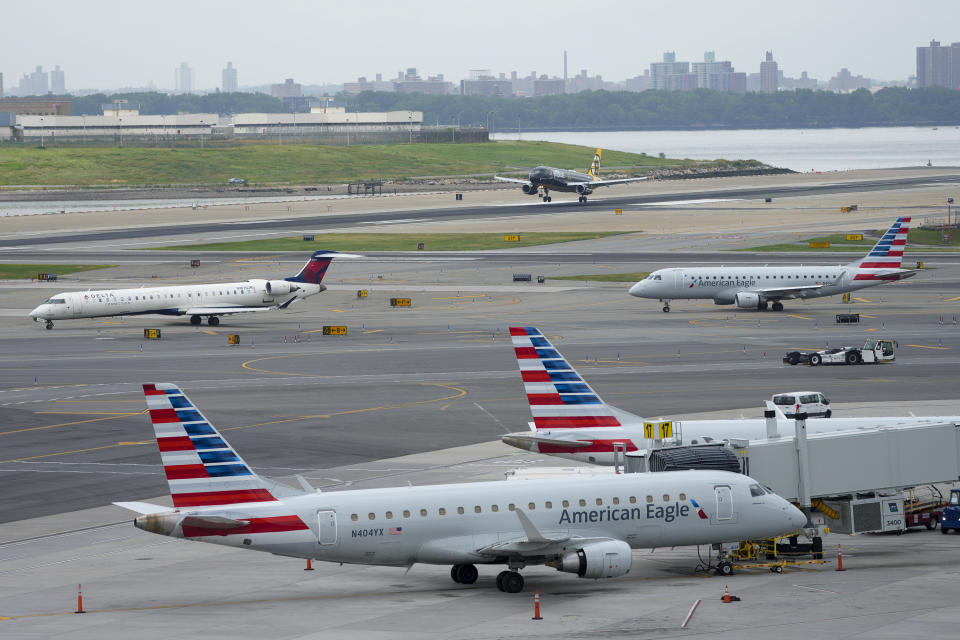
[0,0,960,90]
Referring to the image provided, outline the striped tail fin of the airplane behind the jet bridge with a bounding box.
[510,327,622,430]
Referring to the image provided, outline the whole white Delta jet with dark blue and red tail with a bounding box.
[30,251,359,329]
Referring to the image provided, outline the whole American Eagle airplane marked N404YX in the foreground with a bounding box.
[115,383,807,593]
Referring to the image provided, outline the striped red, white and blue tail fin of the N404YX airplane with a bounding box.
[143,383,276,507]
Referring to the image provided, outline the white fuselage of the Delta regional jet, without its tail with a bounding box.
[30,280,323,320]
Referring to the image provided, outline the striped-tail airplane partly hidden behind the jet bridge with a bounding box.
[501,327,960,465]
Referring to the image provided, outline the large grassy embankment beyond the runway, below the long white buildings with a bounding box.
[0,141,697,186]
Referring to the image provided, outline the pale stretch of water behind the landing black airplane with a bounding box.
[495,126,960,171]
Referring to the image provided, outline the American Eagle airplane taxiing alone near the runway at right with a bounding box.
[630,218,917,313]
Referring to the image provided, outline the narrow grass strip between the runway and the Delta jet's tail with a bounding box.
[157,231,636,252]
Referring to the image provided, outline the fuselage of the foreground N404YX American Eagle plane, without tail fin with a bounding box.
[136,471,806,566]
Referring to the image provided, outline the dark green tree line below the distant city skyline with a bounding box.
[73,87,960,131]
